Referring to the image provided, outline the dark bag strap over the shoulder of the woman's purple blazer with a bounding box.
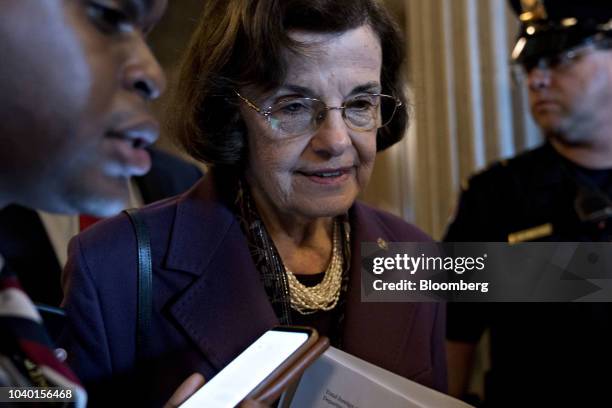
[124,208,153,358]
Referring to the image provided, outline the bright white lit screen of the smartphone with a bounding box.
[180,330,308,408]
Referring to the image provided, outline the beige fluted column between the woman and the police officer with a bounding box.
[365,0,540,239]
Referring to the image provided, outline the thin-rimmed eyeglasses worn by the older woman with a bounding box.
[234,91,402,138]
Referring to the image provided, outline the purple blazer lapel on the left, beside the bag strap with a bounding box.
[166,177,278,370]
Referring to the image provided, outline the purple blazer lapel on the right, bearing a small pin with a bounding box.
[343,203,417,371]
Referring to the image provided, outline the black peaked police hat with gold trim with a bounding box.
[510,0,612,63]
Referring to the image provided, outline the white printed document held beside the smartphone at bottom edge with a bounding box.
[281,347,471,408]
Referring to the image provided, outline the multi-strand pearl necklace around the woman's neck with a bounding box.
[285,220,344,315]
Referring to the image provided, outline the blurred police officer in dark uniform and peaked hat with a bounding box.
[445,0,612,407]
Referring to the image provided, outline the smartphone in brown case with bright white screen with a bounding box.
[180,326,329,408]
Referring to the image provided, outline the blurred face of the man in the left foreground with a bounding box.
[0,0,166,216]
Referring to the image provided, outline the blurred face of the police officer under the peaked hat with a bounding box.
[528,46,612,145]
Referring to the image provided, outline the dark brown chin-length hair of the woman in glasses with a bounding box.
[169,0,408,166]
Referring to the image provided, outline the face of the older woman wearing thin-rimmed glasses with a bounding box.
[241,26,382,218]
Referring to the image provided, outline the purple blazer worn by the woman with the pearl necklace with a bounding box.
[60,177,446,404]
